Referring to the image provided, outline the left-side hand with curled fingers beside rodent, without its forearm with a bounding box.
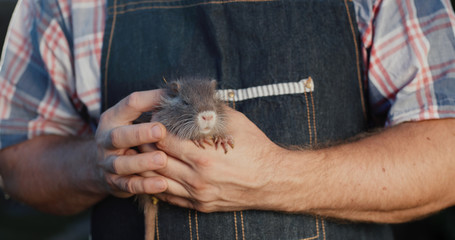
[95,90,171,197]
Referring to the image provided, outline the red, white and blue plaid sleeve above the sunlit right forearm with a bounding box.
[356,0,455,126]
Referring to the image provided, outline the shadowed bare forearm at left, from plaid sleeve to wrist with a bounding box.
[0,136,107,214]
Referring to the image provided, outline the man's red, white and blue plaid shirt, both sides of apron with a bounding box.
[0,0,455,148]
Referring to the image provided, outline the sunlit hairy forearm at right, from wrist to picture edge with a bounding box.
[275,120,455,222]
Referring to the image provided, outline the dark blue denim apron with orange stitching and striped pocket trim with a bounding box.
[92,0,392,240]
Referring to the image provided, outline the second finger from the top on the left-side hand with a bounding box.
[103,123,166,149]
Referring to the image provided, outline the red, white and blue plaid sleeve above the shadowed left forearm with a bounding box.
[0,0,92,148]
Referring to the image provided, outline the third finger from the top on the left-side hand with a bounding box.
[103,151,166,175]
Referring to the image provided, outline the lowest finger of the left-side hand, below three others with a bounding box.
[112,175,168,194]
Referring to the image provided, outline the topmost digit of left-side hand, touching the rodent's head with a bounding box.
[106,89,163,123]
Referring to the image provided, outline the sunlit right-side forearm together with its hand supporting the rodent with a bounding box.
[146,107,455,223]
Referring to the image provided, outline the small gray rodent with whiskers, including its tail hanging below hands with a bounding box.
[138,78,234,240]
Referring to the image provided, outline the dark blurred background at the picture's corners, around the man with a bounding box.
[0,0,455,240]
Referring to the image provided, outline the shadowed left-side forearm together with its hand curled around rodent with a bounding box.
[0,90,167,215]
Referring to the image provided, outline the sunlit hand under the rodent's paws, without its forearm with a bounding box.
[151,109,286,212]
